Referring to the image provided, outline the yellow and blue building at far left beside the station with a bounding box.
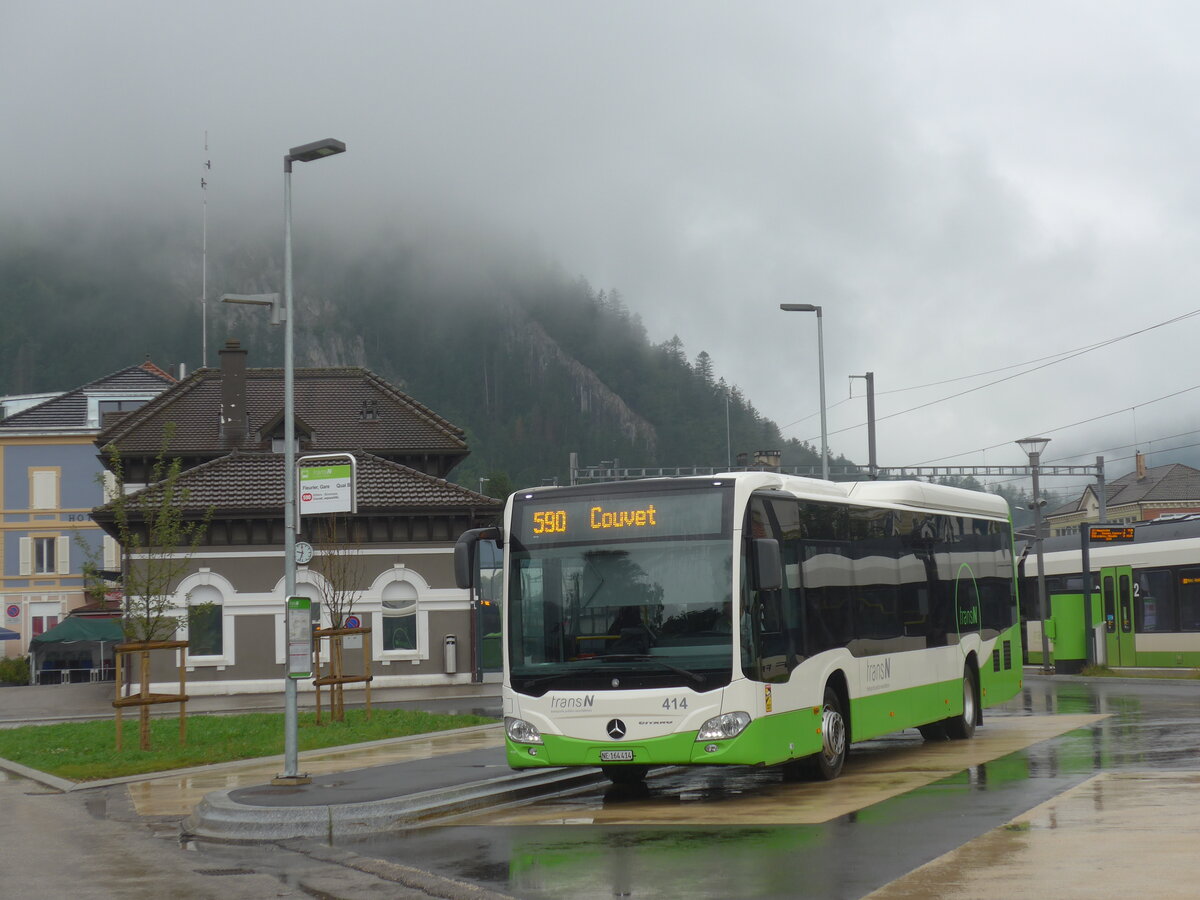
[0,362,175,656]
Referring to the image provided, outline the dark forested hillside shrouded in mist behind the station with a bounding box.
[0,220,840,494]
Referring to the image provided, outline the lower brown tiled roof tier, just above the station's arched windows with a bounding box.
[100,451,502,517]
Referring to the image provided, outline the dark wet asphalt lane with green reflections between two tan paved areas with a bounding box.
[340,677,1200,900]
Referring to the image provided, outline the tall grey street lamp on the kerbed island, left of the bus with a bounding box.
[276,138,346,784]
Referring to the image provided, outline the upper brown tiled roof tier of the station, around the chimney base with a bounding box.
[97,367,467,455]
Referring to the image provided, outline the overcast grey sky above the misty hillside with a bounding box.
[9,0,1200,494]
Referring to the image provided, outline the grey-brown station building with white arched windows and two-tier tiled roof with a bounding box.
[92,342,502,694]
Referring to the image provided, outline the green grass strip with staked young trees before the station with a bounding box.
[0,709,496,781]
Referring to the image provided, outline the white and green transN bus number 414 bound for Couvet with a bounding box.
[455,472,1022,782]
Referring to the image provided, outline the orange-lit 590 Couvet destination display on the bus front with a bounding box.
[512,491,725,544]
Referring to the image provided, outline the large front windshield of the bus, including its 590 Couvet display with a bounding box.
[508,488,733,696]
